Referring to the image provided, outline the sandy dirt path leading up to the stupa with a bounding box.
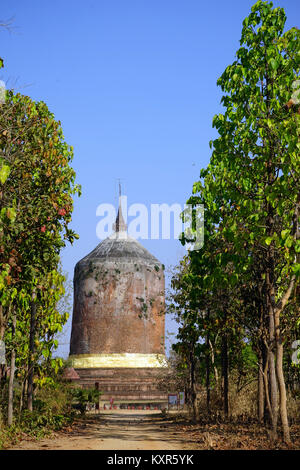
[8,410,193,450]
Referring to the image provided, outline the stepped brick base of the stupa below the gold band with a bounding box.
[70,367,168,407]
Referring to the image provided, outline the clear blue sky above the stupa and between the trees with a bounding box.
[0,0,300,356]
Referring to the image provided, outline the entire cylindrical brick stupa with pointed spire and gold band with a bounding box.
[69,196,167,406]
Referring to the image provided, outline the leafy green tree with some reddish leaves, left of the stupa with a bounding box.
[0,78,80,426]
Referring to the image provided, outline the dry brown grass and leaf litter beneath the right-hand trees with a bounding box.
[182,376,300,450]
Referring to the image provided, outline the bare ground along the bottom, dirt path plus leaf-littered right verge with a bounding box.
[10,410,300,450]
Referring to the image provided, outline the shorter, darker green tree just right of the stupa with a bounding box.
[168,241,245,419]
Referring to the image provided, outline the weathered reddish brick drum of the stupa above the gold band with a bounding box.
[70,235,165,355]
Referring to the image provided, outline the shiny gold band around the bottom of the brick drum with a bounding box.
[69,353,167,369]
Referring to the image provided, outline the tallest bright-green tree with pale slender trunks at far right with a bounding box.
[194,1,300,442]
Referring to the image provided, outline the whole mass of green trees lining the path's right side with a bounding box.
[171,1,300,442]
